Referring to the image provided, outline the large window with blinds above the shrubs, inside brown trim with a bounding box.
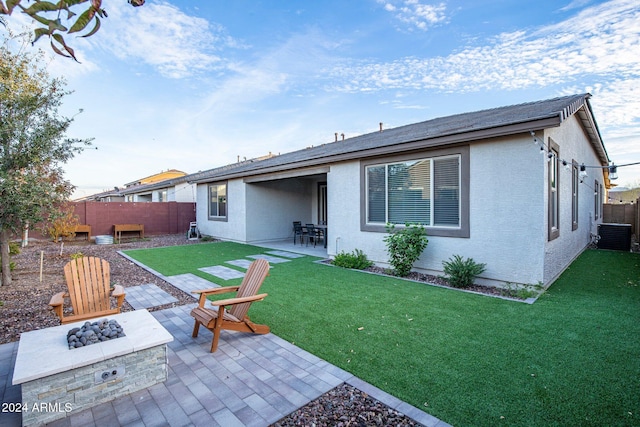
[366,154,461,228]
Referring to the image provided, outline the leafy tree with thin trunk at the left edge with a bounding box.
[0,42,90,286]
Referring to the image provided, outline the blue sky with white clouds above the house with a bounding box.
[1,0,640,196]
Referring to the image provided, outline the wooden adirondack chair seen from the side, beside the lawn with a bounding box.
[191,259,269,353]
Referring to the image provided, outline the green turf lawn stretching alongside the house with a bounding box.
[127,243,640,426]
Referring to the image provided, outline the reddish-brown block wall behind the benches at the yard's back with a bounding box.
[29,202,196,239]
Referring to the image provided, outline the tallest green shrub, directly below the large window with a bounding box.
[384,224,429,277]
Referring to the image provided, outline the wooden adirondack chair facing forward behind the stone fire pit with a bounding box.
[49,257,125,324]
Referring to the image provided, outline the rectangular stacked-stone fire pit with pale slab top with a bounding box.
[13,310,173,426]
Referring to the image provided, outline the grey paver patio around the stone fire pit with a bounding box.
[0,244,448,427]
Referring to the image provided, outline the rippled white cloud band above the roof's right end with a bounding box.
[330,0,640,93]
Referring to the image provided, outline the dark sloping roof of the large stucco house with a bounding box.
[189,93,609,183]
